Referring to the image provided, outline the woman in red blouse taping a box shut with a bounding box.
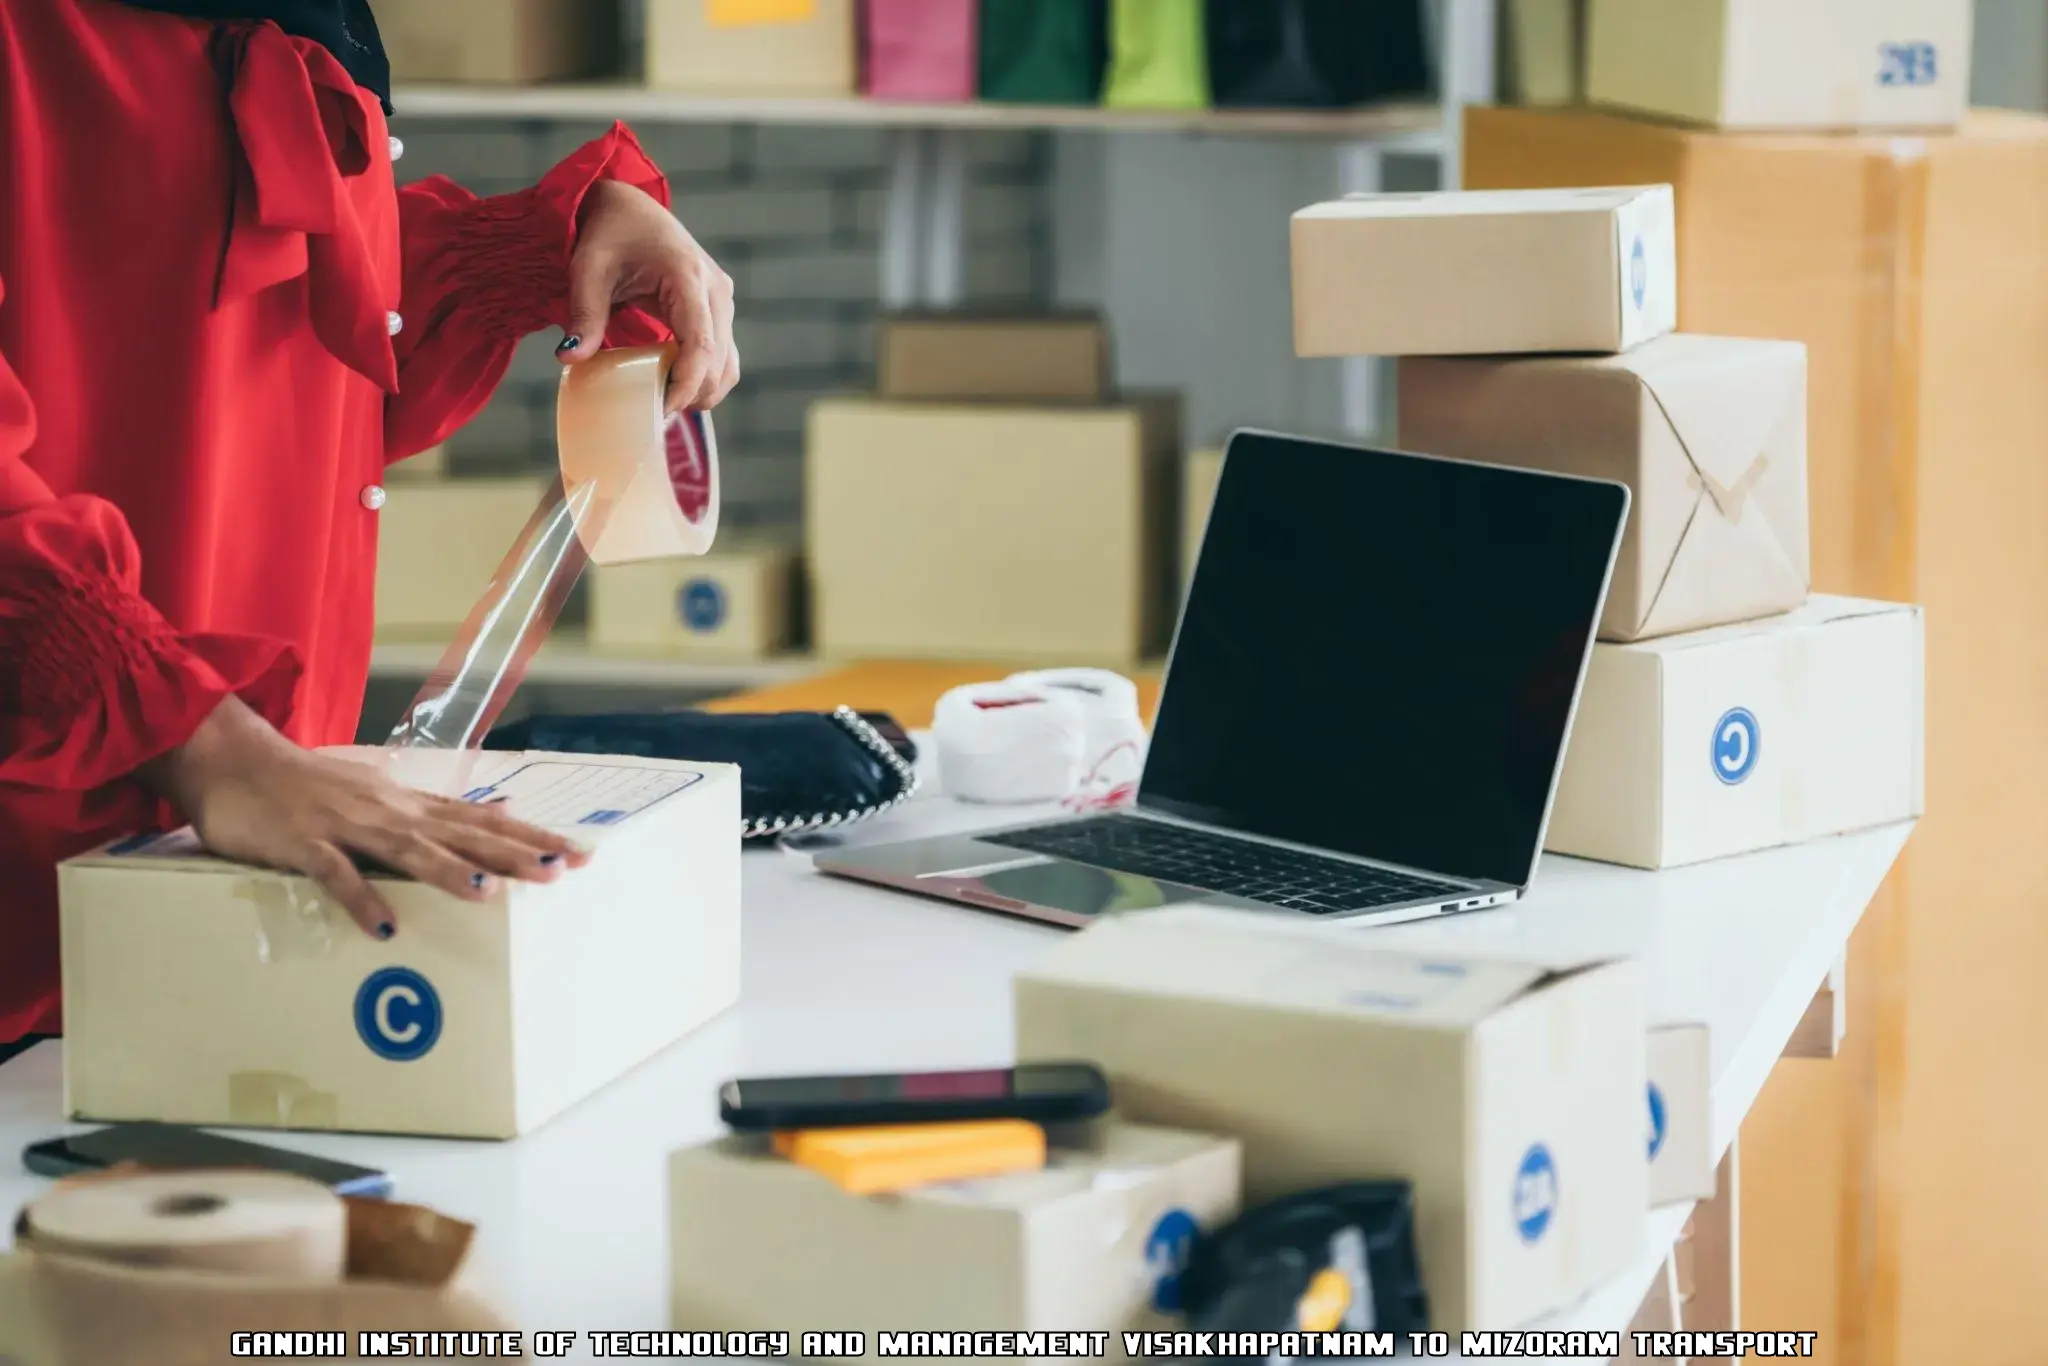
[0,0,739,1055]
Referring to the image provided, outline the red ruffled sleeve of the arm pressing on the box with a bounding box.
[0,274,299,791]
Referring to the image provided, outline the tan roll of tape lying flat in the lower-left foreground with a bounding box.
[23,1171,348,1282]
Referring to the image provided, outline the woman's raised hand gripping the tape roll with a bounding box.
[555,180,739,412]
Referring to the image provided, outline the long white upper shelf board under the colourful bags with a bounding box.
[391,84,1444,150]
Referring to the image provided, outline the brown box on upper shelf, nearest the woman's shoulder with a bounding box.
[377,0,618,86]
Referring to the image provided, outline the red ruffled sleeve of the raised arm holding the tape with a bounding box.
[385,123,670,461]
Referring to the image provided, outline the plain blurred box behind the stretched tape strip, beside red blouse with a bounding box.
[377,477,547,639]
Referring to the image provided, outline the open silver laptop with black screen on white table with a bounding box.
[817,432,1628,926]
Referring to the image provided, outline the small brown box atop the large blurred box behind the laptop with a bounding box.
[879,313,1112,403]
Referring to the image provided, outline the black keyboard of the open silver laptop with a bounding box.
[977,815,1470,915]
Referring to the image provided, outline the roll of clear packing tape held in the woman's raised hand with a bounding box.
[555,342,719,565]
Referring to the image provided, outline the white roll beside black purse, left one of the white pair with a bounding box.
[932,682,1087,805]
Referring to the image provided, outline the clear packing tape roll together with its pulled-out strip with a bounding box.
[385,342,719,750]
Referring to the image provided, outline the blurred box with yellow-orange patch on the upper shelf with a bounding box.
[647,0,860,98]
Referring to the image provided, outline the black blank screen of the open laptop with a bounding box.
[1139,434,1628,887]
